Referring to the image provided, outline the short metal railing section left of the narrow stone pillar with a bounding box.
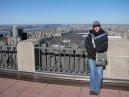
[0,46,17,69]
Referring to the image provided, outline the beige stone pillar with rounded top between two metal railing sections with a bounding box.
[17,39,39,72]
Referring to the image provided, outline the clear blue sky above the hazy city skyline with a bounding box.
[0,0,129,24]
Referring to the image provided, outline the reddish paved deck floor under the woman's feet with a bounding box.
[0,78,129,97]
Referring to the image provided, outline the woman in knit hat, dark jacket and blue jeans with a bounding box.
[85,21,108,95]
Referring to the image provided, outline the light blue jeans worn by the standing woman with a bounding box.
[88,59,103,92]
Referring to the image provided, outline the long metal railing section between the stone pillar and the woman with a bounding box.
[35,47,89,75]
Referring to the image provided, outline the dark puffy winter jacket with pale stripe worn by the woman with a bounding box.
[85,29,108,60]
